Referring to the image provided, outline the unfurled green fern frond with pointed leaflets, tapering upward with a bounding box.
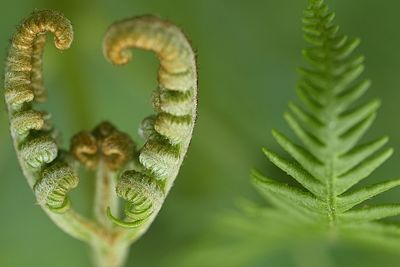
[253,0,400,239]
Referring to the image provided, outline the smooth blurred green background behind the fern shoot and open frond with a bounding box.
[0,0,400,267]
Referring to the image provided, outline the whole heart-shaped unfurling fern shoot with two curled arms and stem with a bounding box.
[5,11,197,267]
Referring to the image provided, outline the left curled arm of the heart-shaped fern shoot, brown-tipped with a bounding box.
[5,10,78,213]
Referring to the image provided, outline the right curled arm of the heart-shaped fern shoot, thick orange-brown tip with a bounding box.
[103,16,197,227]
